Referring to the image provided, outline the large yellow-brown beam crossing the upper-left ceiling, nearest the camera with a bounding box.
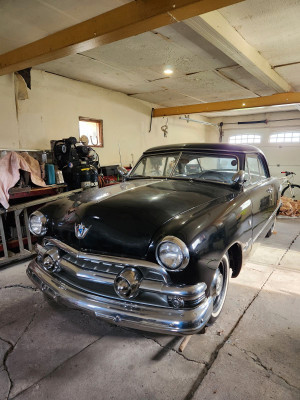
[0,0,243,75]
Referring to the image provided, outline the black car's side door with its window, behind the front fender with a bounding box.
[245,154,275,241]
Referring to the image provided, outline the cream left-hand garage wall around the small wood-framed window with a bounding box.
[0,70,218,165]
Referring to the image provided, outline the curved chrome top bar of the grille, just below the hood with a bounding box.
[43,237,171,283]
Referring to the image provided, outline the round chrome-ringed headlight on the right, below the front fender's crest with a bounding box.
[156,236,190,271]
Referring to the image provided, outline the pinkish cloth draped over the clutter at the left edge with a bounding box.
[0,151,46,208]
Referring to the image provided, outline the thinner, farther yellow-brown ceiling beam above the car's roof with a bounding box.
[153,92,300,117]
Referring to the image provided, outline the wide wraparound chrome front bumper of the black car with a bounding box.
[27,260,213,335]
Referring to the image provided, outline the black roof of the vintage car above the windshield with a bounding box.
[144,143,263,154]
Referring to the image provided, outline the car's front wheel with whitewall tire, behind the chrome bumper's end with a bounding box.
[208,253,230,324]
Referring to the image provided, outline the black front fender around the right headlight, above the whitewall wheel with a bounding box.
[148,192,252,288]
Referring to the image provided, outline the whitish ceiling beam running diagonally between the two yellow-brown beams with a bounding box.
[184,11,293,93]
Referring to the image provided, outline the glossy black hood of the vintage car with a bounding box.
[41,179,233,258]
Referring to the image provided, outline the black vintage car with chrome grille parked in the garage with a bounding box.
[27,143,280,334]
